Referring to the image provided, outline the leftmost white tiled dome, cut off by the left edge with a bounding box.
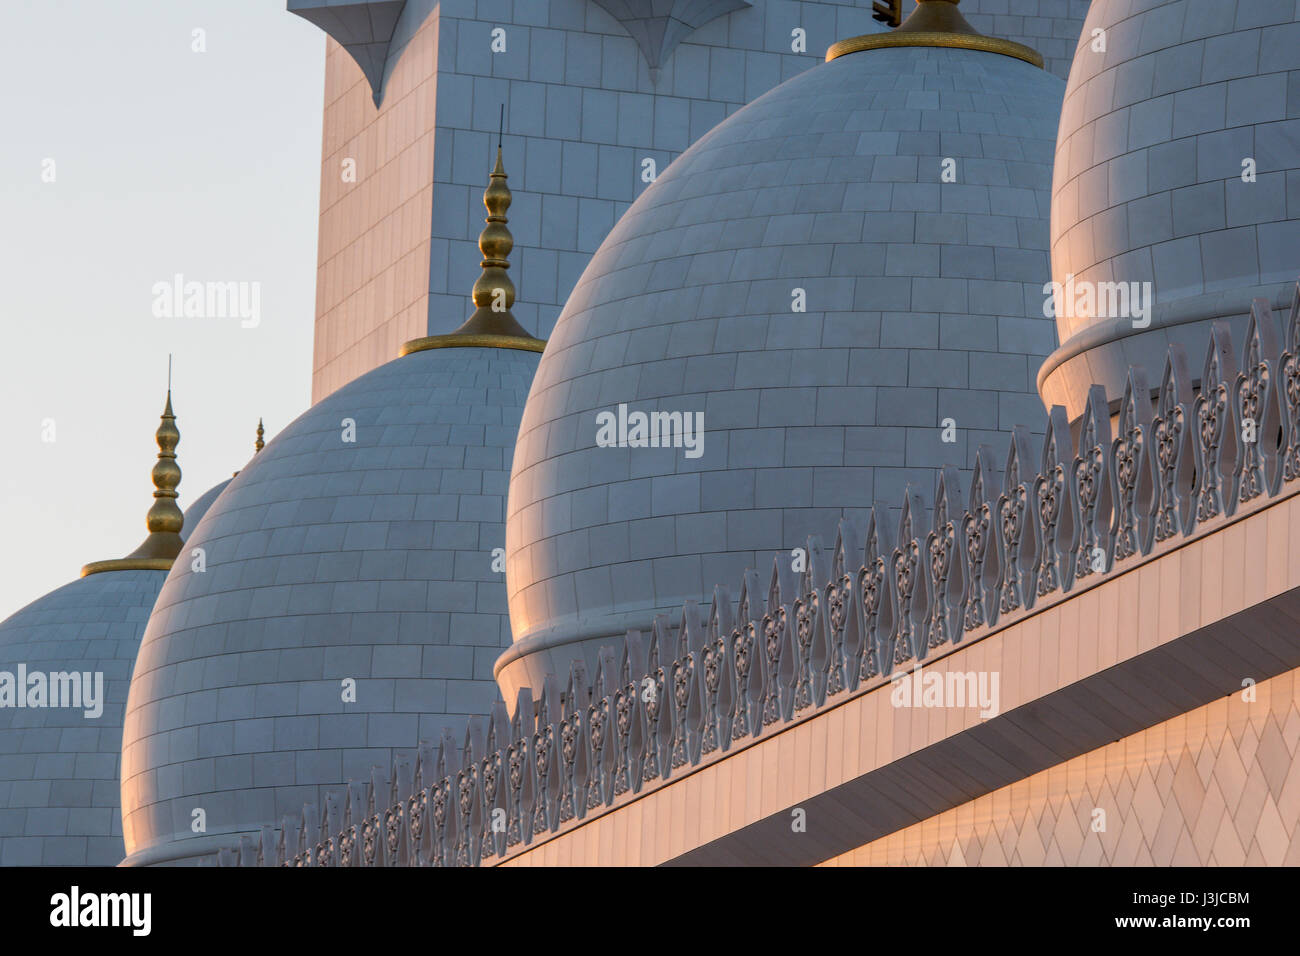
[0,571,166,866]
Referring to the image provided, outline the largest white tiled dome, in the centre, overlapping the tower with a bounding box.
[497,31,1063,700]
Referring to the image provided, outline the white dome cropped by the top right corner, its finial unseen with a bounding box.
[1039,0,1300,418]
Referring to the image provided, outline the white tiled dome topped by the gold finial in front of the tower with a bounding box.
[122,349,538,864]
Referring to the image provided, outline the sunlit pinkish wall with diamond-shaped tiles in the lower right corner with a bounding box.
[823,670,1300,866]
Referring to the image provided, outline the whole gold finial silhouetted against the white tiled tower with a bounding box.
[402,136,546,355]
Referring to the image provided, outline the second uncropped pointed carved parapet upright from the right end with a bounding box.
[1195,321,1238,523]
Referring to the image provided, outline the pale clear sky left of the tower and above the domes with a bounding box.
[0,0,325,619]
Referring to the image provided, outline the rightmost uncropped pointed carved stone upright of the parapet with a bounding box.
[1232,299,1282,507]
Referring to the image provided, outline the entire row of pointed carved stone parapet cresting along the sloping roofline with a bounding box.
[218,282,1300,866]
